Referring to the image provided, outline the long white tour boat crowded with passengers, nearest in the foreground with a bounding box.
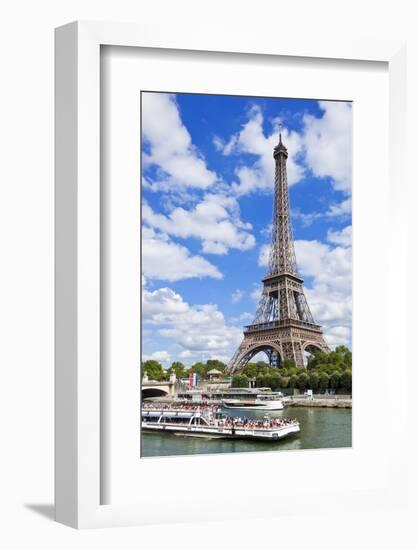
[142,408,300,441]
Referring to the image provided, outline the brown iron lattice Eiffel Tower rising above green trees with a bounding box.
[227,134,330,374]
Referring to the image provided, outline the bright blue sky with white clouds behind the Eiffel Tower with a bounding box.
[141,92,352,366]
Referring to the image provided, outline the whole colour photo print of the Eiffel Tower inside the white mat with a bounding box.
[140,91,352,457]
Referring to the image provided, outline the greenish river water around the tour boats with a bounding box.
[141,407,352,457]
